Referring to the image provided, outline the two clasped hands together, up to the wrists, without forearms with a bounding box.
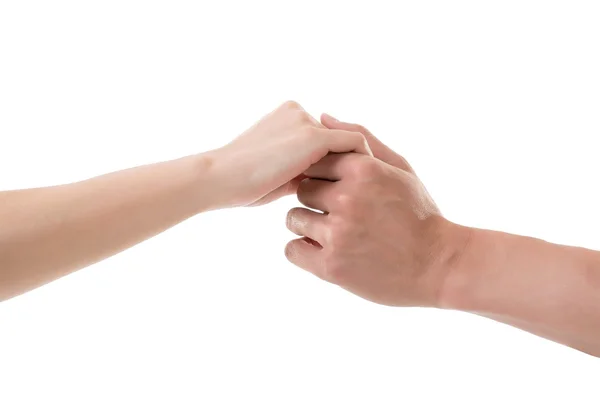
[209,102,469,307]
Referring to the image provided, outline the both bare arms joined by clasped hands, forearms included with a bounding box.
[0,102,600,356]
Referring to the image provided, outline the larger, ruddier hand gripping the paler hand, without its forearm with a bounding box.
[286,116,467,306]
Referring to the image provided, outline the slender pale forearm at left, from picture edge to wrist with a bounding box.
[0,155,217,300]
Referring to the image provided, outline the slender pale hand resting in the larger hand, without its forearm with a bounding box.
[213,101,372,207]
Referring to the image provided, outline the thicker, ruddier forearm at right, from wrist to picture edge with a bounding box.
[443,225,600,356]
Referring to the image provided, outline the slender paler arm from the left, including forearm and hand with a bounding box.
[0,102,372,300]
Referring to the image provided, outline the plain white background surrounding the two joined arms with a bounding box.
[0,0,600,400]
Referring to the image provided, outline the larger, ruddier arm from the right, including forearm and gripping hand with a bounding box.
[286,115,600,356]
